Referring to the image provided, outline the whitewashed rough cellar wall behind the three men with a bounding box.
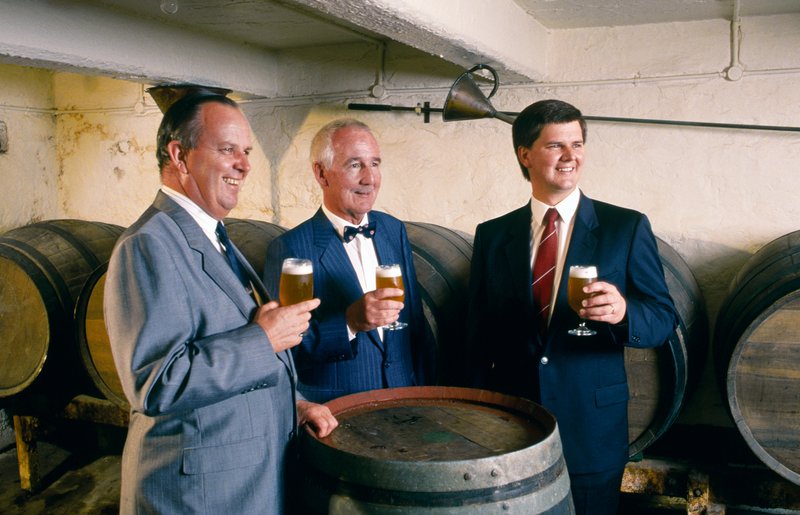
[0,16,800,436]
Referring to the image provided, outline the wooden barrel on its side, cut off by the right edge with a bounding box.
[713,231,800,485]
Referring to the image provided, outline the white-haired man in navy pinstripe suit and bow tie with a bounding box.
[264,118,434,402]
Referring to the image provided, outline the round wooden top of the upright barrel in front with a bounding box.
[324,387,552,461]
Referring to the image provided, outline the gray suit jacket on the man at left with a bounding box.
[104,192,296,514]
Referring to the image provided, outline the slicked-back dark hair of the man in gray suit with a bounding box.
[156,90,239,171]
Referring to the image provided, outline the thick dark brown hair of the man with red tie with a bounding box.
[511,99,586,181]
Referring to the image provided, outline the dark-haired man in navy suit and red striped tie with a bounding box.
[468,100,678,514]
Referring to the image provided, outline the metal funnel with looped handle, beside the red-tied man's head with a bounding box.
[442,64,516,123]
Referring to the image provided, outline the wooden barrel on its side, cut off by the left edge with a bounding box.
[0,220,122,408]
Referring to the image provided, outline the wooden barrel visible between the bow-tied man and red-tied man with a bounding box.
[404,222,472,385]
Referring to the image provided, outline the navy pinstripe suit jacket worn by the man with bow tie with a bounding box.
[264,209,434,402]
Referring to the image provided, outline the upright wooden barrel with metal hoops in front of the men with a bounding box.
[301,387,574,515]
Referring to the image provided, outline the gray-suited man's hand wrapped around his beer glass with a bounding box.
[253,299,320,352]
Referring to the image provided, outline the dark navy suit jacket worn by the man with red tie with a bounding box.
[468,195,678,473]
